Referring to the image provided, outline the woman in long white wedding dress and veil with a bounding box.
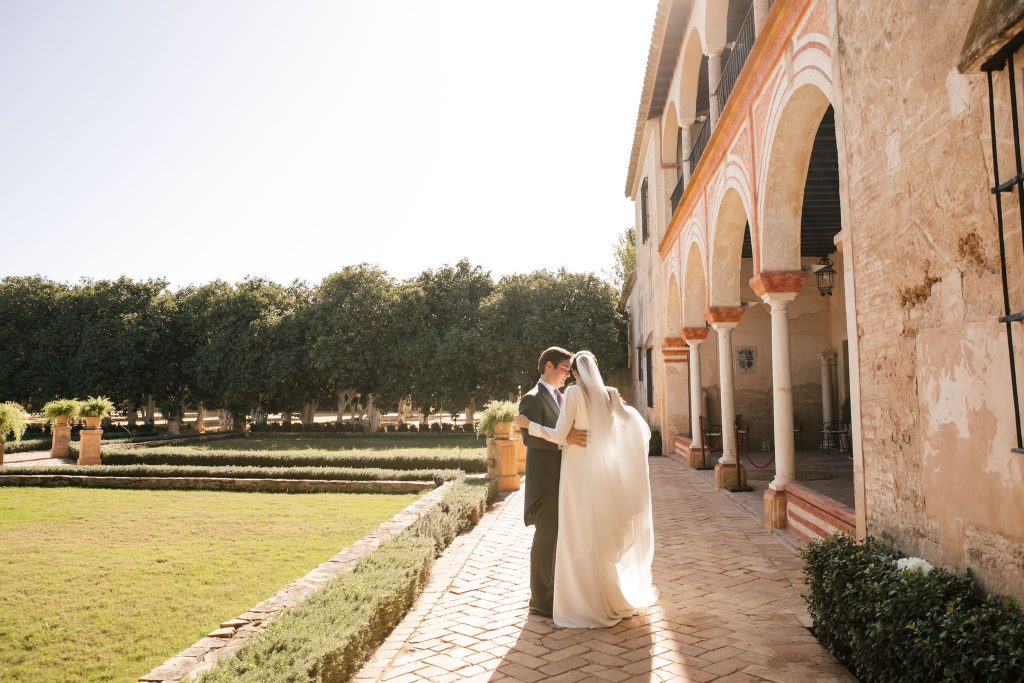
[516,351,657,628]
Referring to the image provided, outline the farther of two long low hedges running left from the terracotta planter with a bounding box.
[101,446,487,474]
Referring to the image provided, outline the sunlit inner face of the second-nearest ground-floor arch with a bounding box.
[709,182,750,306]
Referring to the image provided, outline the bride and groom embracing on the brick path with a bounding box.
[516,346,657,628]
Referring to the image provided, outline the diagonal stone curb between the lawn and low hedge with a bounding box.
[138,482,452,683]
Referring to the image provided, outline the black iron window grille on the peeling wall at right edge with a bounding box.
[982,46,1024,455]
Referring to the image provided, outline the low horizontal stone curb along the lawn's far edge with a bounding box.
[0,474,436,494]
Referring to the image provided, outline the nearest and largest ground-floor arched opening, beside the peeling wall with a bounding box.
[760,84,855,523]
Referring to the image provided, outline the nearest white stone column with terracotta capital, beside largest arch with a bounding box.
[751,270,807,528]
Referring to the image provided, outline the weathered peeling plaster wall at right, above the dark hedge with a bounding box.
[833,0,1024,596]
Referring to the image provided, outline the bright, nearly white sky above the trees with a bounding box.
[0,0,656,286]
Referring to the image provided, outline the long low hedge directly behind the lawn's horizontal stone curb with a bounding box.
[0,465,463,481]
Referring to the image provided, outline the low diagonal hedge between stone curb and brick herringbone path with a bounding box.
[198,480,498,683]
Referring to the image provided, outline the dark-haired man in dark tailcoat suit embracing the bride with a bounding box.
[519,346,587,616]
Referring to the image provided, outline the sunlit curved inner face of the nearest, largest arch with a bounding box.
[756,81,831,272]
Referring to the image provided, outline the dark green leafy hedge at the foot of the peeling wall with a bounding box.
[802,535,1024,681]
